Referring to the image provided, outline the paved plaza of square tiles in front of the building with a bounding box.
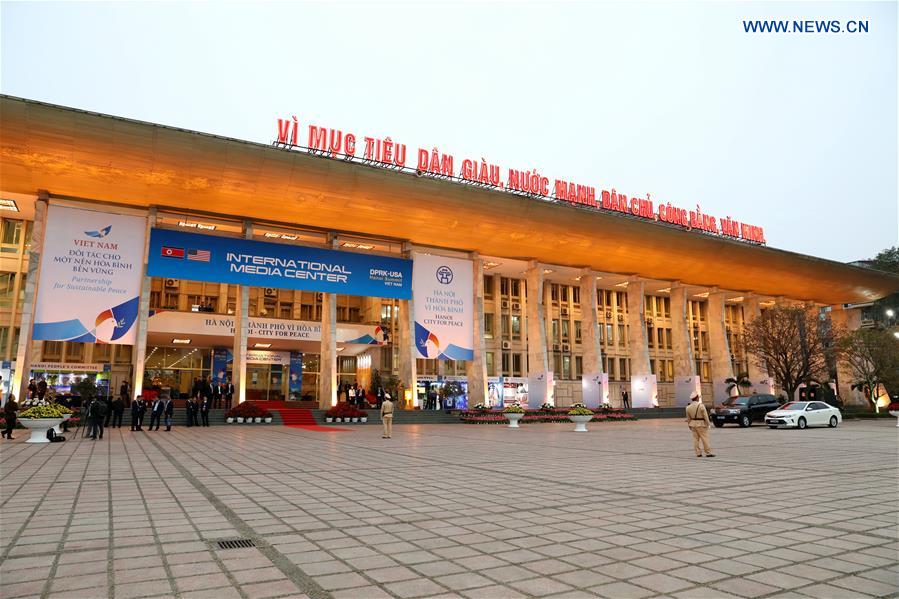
[0,420,899,599]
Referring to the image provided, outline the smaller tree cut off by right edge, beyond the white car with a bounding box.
[843,329,899,412]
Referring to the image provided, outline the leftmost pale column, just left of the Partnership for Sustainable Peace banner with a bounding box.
[10,191,49,403]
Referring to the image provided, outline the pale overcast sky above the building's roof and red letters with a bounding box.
[0,2,899,261]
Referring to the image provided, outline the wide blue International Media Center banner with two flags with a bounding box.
[147,229,412,299]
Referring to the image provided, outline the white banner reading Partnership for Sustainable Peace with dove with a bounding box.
[33,205,147,345]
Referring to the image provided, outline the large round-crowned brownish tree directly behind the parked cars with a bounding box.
[743,306,842,401]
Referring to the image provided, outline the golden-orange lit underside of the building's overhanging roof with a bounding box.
[0,96,899,304]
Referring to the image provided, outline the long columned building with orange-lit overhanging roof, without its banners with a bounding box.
[0,97,899,408]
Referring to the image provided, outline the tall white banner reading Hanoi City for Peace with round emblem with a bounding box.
[412,254,474,360]
